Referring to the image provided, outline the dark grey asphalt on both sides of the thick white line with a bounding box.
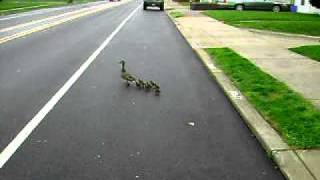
[0,1,283,180]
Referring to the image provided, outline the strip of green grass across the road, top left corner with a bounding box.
[0,0,95,15]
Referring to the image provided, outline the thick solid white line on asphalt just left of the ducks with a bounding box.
[0,5,141,168]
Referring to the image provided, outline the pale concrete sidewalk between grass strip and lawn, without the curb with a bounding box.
[171,3,320,108]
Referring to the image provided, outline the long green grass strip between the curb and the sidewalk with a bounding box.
[206,48,320,148]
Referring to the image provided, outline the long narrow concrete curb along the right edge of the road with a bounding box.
[166,8,317,180]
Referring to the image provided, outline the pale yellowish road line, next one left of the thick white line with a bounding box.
[0,0,130,44]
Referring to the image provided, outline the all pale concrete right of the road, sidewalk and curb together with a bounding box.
[167,2,320,180]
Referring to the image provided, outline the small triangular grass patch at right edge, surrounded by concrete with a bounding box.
[290,45,320,62]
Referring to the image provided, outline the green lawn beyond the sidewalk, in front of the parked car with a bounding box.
[204,10,320,36]
